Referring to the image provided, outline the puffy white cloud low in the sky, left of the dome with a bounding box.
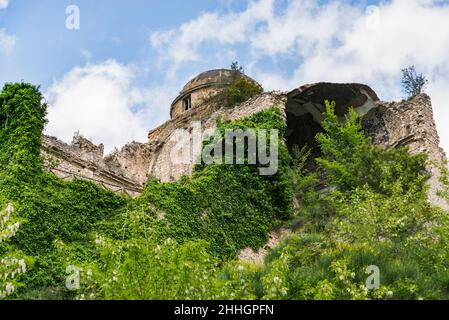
[45,60,168,152]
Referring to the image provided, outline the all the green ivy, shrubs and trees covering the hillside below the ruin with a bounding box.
[0,83,449,299]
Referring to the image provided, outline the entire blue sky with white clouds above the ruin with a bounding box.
[0,0,449,155]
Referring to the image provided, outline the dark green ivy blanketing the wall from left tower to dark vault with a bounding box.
[0,83,292,298]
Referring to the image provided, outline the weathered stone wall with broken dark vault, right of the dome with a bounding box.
[148,83,447,207]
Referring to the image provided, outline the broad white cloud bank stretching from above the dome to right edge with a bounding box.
[150,0,449,151]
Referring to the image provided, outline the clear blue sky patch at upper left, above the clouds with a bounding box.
[0,0,231,88]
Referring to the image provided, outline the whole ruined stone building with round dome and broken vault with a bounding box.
[42,69,445,208]
